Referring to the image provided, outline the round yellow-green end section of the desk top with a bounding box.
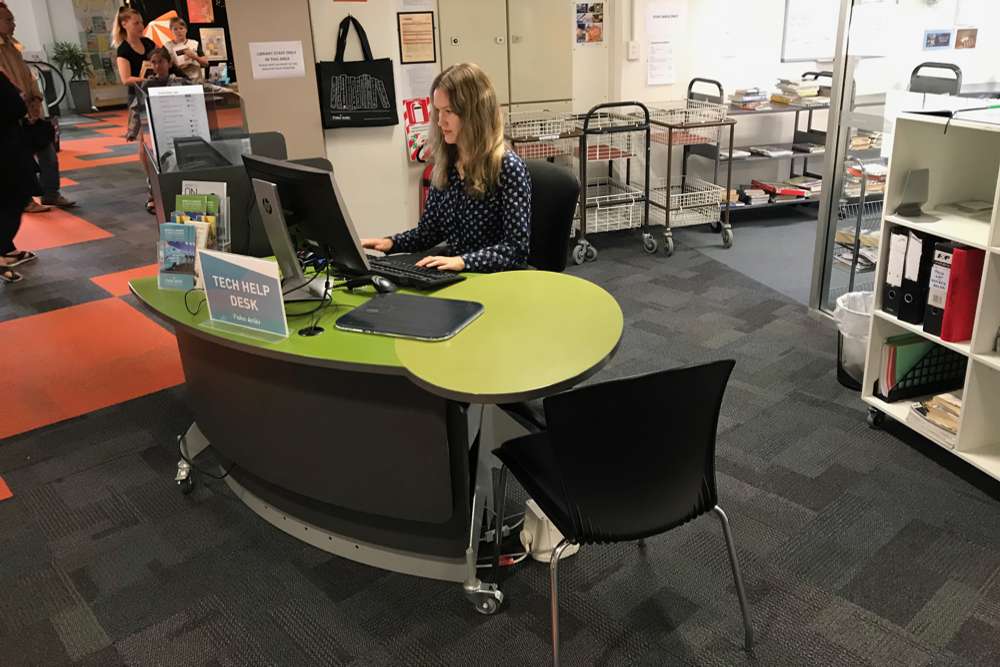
[396,271,623,403]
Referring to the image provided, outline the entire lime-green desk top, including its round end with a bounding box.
[130,271,623,403]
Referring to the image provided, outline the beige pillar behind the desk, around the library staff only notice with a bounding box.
[226,0,326,159]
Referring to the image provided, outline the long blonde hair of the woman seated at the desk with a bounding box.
[431,63,505,198]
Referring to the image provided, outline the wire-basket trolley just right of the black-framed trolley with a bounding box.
[645,78,736,257]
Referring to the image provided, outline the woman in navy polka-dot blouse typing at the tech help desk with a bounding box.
[361,64,531,273]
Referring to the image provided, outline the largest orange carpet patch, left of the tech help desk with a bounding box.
[0,298,184,439]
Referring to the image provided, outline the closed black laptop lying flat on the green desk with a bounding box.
[337,292,483,340]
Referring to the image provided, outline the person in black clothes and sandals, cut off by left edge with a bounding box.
[0,72,38,284]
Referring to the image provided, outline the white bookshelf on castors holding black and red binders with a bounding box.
[861,114,1000,479]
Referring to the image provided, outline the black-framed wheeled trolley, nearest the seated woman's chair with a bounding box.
[572,102,657,264]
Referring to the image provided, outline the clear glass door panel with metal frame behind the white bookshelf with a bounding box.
[810,0,1000,312]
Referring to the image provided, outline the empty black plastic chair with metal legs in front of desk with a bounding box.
[494,360,753,665]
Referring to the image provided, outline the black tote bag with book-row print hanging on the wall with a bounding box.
[316,16,399,129]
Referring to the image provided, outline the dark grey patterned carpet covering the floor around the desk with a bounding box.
[0,171,1000,667]
